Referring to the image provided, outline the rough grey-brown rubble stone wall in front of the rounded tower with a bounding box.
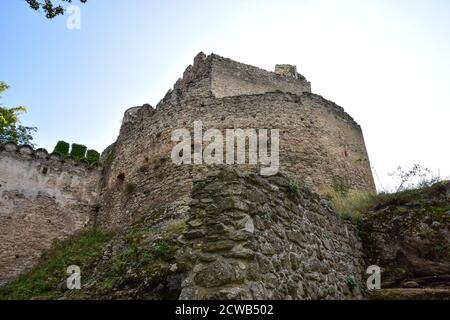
[180,169,364,299]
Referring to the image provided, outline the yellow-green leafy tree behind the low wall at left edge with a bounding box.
[0,81,36,146]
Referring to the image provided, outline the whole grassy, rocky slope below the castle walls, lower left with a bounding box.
[0,222,185,300]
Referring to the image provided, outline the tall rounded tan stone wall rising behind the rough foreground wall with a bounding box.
[98,54,375,228]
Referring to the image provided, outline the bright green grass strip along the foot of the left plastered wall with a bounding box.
[0,232,111,300]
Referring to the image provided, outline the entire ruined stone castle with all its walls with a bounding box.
[0,53,375,299]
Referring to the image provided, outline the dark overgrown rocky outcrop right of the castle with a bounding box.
[361,181,450,293]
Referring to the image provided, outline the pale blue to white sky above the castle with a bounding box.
[0,0,450,187]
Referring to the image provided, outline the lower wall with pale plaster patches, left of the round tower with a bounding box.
[0,143,99,284]
